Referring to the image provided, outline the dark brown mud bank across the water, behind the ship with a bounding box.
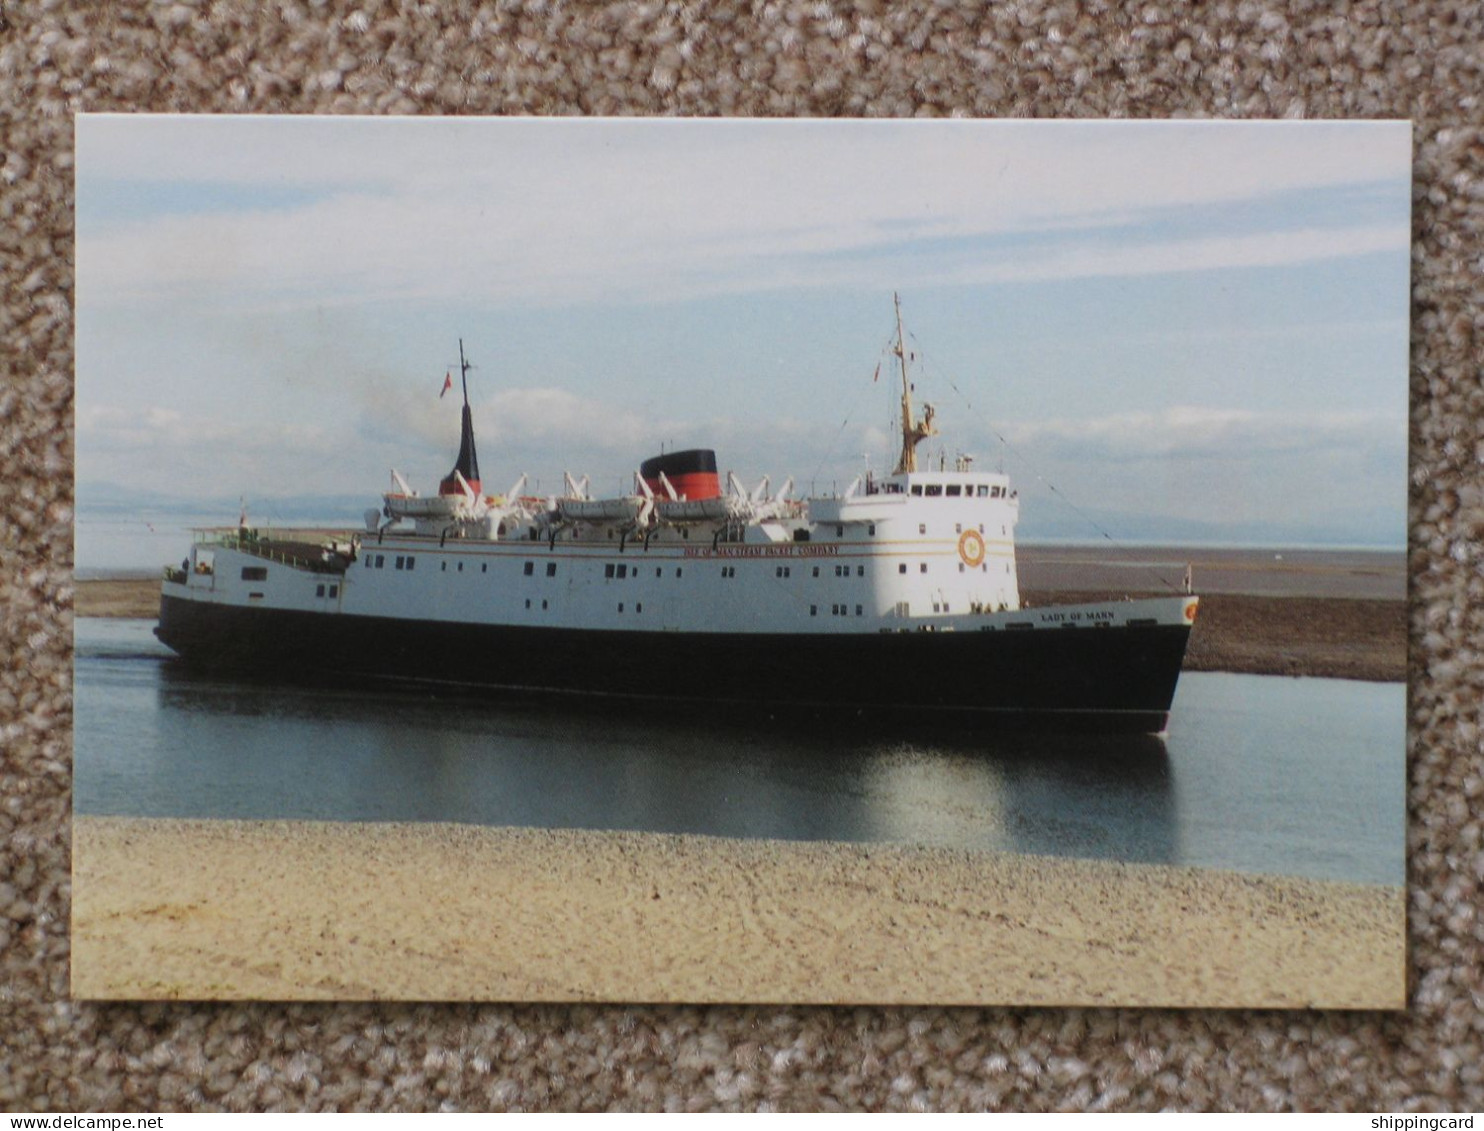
[74,577,1407,683]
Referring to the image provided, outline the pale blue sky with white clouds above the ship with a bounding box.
[76,114,1411,567]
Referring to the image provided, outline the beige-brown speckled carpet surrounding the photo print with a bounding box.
[0,0,1484,1110]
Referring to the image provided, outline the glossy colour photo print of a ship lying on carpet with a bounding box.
[73,116,1411,1008]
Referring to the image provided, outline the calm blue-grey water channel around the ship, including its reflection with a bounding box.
[74,617,1405,883]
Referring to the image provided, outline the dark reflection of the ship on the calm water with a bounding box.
[147,663,1175,861]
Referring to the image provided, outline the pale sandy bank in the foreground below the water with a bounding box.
[71,818,1405,1008]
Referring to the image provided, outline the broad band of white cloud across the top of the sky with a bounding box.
[79,119,1410,313]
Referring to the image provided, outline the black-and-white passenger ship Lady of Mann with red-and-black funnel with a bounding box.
[156,297,1199,733]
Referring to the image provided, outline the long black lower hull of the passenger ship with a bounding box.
[156,597,1190,733]
